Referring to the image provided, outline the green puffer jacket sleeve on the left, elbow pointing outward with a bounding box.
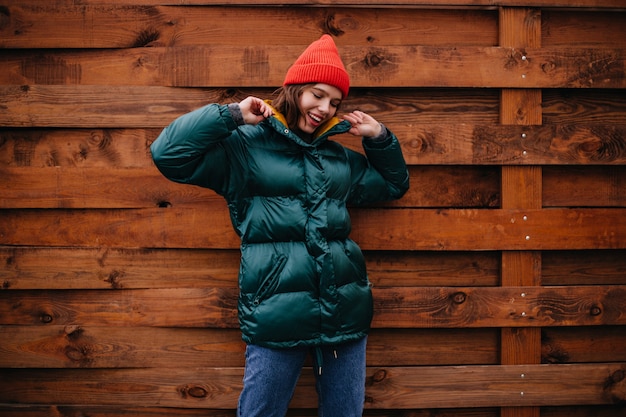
[150,104,237,193]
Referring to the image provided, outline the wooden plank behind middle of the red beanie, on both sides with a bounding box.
[0,45,626,88]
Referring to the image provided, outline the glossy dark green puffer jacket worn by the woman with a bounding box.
[151,104,409,348]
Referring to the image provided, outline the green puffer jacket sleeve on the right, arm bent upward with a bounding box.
[349,128,409,205]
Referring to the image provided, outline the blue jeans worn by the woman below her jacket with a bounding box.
[237,338,367,417]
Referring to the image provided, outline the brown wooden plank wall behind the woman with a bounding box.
[0,0,626,417]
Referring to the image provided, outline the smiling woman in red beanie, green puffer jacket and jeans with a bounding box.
[151,35,409,417]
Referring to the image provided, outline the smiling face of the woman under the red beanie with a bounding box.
[298,83,341,133]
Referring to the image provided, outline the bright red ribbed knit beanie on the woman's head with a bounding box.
[283,35,350,98]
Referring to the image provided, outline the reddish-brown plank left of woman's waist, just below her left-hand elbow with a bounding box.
[0,205,240,249]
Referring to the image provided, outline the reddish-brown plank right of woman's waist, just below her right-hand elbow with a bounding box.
[352,209,626,250]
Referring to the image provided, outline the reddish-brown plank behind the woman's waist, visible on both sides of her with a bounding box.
[0,206,626,251]
